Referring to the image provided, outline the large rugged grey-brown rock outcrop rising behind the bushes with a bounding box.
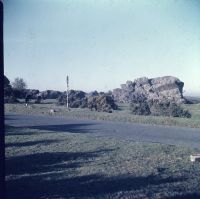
[112,76,186,104]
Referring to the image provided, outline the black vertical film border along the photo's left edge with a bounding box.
[0,1,5,199]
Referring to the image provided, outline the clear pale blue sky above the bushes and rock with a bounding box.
[4,0,200,96]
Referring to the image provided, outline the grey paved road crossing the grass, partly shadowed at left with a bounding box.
[5,114,200,148]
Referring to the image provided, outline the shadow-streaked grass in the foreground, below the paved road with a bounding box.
[5,127,200,199]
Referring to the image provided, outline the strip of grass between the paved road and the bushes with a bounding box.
[5,101,200,128]
